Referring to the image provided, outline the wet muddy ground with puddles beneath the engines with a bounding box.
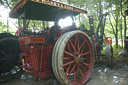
[0,58,128,85]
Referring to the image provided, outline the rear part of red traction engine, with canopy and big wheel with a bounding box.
[10,0,112,85]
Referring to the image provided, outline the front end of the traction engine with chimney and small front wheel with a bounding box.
[88,13,113,66]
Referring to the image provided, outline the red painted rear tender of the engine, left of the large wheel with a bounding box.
[19,35,53,79]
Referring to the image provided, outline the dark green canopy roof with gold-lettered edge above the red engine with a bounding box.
[9,0,87,21]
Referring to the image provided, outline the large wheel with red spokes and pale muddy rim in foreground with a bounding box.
[52,30,94,85]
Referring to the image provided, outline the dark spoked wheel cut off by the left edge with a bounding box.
[0,33,21,79]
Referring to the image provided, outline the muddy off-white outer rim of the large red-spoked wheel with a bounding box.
[52,31,94,84]
